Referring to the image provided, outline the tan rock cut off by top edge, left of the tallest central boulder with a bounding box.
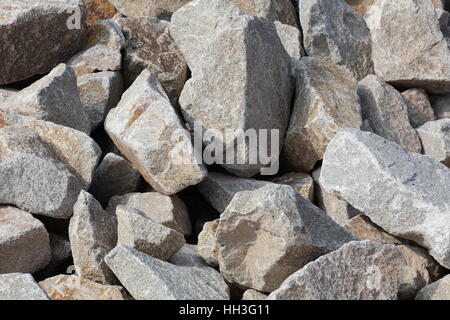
[109,0,191,20]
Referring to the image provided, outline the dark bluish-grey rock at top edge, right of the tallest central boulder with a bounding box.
[299,0,373,80]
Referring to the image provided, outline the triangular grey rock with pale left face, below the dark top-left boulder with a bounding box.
[5,64,91,133]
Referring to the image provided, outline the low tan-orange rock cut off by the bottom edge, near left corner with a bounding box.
[39,275,129,300]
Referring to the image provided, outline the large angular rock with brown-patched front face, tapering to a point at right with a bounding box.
[216,184,354,292]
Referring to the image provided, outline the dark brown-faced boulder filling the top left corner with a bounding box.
[0,0,86,85]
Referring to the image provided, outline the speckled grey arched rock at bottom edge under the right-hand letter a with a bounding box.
[269,241,405,300]
